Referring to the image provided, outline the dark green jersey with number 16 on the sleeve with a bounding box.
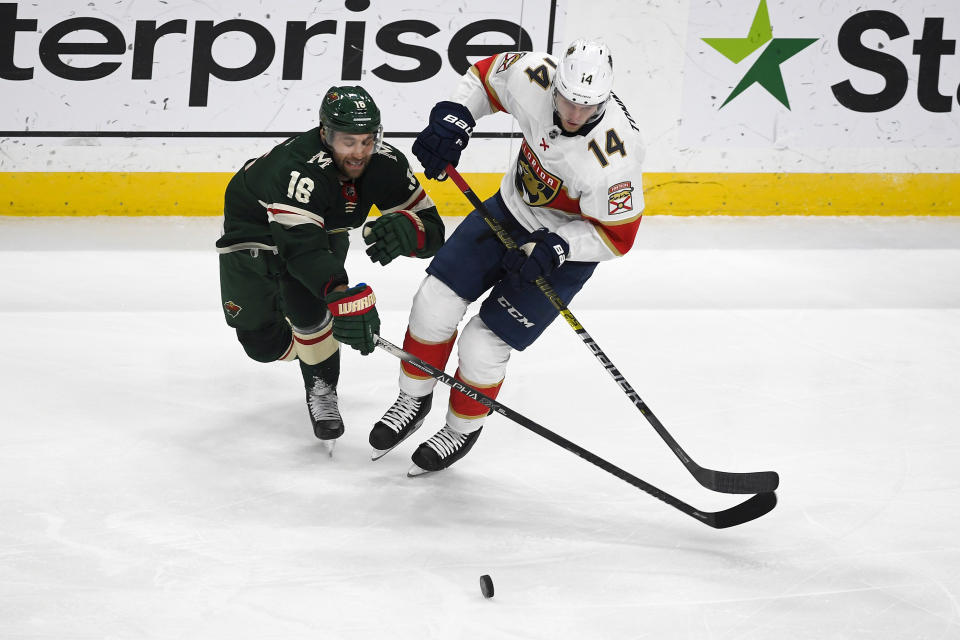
[217,127,444,297]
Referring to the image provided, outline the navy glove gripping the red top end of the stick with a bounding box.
[413,101,477,180]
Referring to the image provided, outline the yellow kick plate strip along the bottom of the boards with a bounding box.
[0,172,960,216]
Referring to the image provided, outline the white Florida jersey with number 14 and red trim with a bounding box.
[452,52,644,262]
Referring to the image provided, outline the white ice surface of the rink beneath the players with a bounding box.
[0,217,960,640]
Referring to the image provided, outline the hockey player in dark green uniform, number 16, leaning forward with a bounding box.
[217,86,444,453]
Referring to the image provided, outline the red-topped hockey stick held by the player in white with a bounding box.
[446,164,780,493]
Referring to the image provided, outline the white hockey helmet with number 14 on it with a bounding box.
[553,38,613,114]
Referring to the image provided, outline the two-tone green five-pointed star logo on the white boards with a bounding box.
[703,0,817,109]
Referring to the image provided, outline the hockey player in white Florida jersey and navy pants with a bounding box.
[370,40,644,475]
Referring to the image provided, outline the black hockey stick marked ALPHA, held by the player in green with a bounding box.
[374,335,777,529]
